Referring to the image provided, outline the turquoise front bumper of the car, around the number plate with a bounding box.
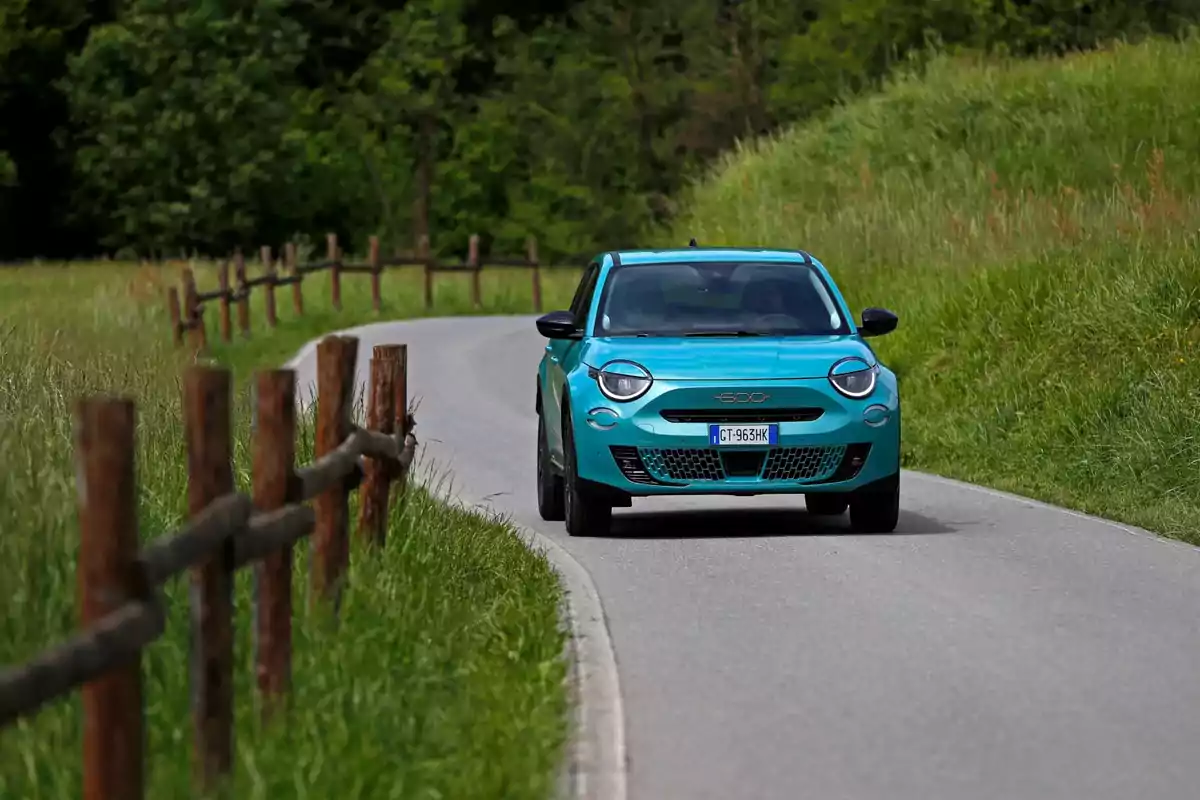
[571,379,900,497]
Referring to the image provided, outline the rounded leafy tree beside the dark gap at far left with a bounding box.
[64,0,305,251]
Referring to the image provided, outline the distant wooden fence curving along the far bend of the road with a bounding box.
[167,234,588,349]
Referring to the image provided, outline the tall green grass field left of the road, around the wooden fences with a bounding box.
[0,265,574,800]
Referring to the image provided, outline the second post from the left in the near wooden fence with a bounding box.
[184,367,234,792]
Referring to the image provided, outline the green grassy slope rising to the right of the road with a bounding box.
[671,32,1200,542]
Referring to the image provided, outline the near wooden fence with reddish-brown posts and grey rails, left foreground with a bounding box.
[0,336,416,800]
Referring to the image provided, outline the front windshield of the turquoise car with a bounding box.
[595,261,850,336]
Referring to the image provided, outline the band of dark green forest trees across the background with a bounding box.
[0,0,1200,258]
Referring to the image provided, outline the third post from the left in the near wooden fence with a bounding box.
[252,369,296,720]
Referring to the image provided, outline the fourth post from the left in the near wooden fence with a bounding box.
[311,336,359,609]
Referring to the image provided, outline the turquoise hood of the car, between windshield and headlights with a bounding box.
[581,336,875,380]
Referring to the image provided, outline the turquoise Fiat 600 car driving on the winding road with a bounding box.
[535,240,900,536]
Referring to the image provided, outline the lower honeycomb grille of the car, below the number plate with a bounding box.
[638,445,846,483]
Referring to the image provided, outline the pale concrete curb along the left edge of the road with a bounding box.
[283,323,628,800]
